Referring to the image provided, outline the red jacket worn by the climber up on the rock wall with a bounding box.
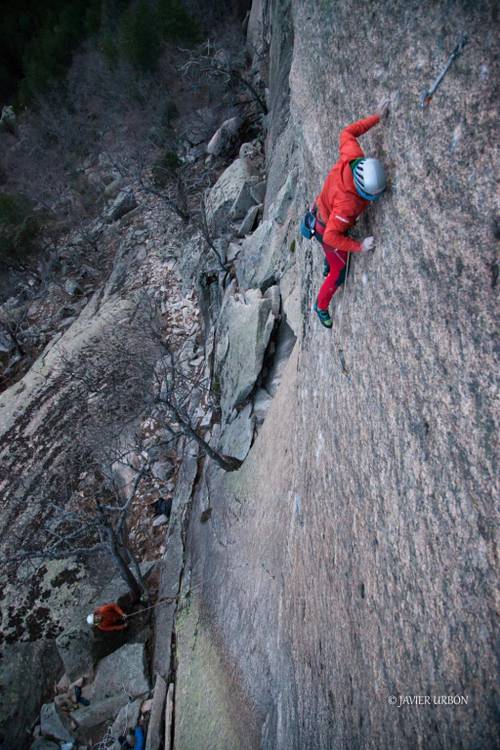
[316,115,380,253]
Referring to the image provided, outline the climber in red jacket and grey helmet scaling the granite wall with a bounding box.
[313,99,389,328]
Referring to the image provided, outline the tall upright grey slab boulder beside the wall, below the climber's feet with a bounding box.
[216,289,274,417]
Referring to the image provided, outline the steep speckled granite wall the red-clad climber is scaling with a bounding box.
[176,0,498,750]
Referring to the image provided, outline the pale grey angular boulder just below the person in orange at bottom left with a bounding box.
[90,643,149,701]
